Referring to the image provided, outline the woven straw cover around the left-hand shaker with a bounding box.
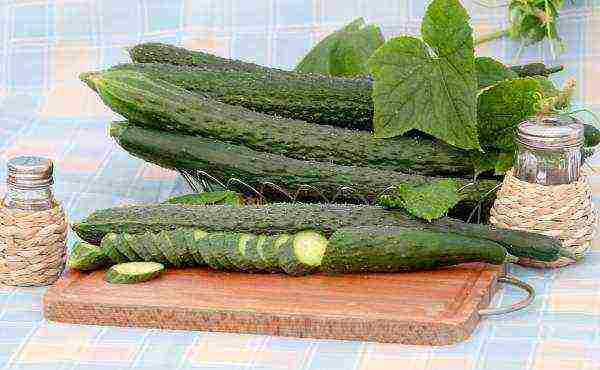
[0,206,68,286]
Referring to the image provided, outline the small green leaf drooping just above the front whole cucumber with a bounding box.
[378,179,460,221]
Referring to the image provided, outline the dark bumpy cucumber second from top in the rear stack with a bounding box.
[110,63,373,131]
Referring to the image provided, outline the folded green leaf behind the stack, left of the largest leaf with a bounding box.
[296,18,384,77]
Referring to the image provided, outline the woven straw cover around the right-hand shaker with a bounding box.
[490,171,597,268]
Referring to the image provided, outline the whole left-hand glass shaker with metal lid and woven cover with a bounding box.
[0,156,68,286]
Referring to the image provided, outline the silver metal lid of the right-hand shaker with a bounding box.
[517,116,585,149]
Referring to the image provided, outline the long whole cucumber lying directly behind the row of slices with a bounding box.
[72,203,565,262]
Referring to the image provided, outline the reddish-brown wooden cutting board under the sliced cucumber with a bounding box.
[44,263,503,345]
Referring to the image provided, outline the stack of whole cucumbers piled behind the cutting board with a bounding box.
[81,43,600,214]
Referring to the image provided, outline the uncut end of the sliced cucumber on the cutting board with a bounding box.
[320,227,506,274]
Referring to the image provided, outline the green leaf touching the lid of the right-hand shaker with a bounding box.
[478,78,542,152]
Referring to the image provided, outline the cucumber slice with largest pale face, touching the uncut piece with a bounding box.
[279,231,329,276]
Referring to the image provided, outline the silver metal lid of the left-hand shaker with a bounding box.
[7,156,54,189]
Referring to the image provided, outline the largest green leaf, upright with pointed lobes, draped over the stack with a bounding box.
[369,0,480,149]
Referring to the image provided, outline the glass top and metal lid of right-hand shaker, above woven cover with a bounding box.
[514,116,584,185]
